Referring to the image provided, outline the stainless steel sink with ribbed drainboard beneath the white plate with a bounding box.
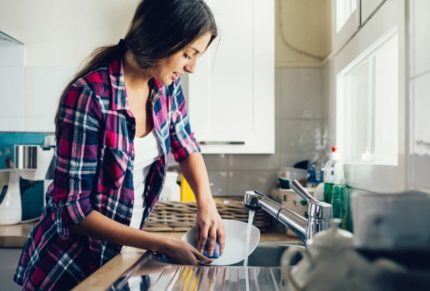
[110,243,304,291]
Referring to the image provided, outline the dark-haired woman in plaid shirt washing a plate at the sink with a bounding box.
[14,0,224,289]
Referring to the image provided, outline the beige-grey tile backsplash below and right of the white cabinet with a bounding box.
[204,67,323,196]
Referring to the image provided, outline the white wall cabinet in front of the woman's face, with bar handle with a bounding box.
[188,0,275,154]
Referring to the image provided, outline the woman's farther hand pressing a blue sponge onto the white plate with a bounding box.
[194,203,225,256]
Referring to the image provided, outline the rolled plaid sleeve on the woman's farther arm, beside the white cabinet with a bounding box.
[169,79,200,162]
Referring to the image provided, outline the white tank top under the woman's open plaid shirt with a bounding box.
[130,130,161,229]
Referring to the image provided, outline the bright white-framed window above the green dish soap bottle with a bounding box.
[336,30,399,166]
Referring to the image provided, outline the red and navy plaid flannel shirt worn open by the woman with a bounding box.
[14,59,200,290]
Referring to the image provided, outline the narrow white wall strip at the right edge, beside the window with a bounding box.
[408,0,430,192]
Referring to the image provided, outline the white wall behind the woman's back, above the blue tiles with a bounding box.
[0,0,139,131]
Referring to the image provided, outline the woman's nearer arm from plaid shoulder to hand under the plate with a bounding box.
[53,86,207,264]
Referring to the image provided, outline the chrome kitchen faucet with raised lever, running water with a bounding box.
[244,180,332,243]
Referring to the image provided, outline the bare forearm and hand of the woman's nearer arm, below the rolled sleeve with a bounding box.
[71,210,211,265]
